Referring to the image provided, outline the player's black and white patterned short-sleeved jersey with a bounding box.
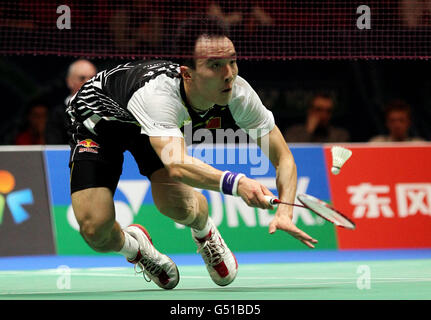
[67,60,275,138]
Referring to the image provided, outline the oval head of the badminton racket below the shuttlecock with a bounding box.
[296,194,356,230]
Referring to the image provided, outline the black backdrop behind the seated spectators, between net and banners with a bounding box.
[0,55,431,144]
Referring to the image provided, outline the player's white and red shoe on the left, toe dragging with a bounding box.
[124,224,180,289]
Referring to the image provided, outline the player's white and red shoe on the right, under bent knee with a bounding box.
[192,218,238,286]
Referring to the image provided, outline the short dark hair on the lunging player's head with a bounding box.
[173,16,229,69]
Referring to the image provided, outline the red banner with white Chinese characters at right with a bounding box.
[325,145,431,249]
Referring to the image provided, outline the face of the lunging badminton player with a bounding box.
[192,37,238,107]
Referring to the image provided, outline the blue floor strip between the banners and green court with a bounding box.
[0,248,431,270]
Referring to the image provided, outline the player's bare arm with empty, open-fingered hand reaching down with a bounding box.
[257,126,317,248]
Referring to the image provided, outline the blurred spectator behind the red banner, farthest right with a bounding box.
[370,100,425,142]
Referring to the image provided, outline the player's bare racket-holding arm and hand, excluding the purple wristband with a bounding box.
[150,137,274,209]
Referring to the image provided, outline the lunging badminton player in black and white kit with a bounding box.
[67,19,317,289]
